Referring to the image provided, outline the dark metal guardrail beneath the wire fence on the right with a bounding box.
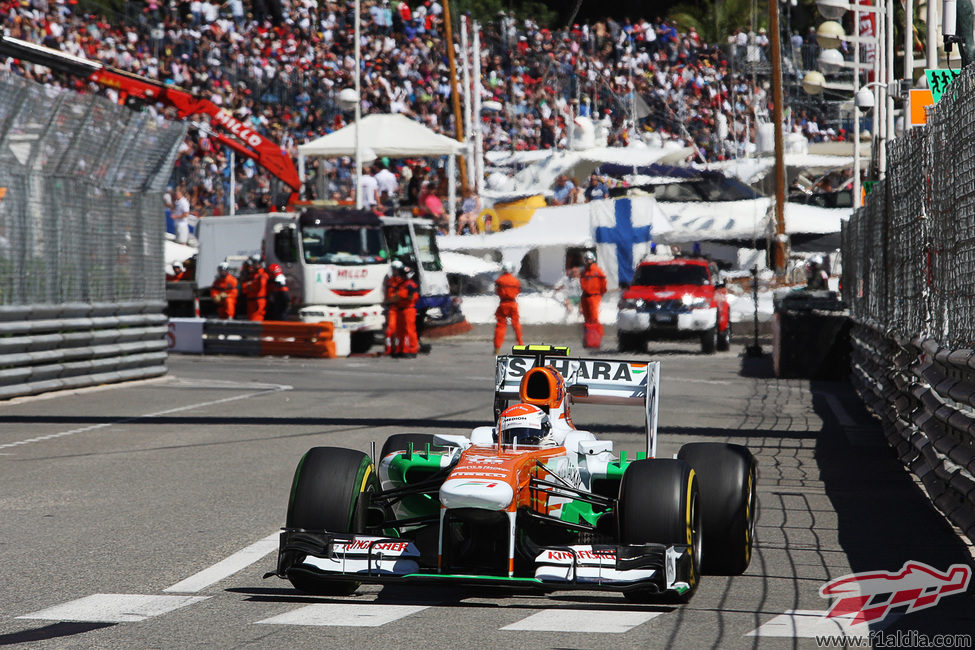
[852,326,975,539]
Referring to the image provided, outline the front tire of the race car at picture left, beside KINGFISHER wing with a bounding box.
[286,447,380,596]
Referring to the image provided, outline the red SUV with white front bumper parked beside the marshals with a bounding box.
[616,258,731,354]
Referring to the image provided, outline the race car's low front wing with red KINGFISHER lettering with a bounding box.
[265,528,694,594]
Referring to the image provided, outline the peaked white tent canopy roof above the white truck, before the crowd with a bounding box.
[298,114,465,158]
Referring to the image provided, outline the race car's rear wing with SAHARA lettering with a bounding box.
[494,345,660,458]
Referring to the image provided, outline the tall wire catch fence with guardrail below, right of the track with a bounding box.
[842,68,975,539]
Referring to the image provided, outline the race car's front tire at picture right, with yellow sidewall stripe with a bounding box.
[617,458,702,602]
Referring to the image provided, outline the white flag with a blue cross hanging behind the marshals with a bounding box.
[589,196,670,289]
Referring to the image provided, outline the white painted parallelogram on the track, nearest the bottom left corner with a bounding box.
[17,594,209,623]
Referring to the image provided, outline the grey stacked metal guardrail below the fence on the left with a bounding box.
[0,301,167,399]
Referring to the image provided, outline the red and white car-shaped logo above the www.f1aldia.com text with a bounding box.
[819,561,972,625]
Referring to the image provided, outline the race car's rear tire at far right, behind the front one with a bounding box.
[677,442,758,575]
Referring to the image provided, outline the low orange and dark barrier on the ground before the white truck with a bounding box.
[203,320,337,359]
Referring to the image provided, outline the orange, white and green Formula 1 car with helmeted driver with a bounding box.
[265,346,757,602]
